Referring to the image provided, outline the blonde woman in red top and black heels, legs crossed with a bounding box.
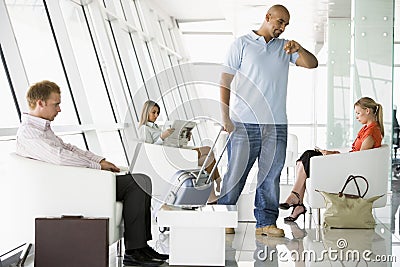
[279,97,384,222]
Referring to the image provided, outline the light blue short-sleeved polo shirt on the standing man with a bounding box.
[224,31,299,124]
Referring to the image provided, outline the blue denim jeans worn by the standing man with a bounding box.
[218,122,287,228]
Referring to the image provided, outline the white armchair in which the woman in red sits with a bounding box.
[306,144,390,224]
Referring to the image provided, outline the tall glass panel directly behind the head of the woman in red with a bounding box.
[351,1,394,149]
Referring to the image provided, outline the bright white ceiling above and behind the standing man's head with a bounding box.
[155,0,351,53]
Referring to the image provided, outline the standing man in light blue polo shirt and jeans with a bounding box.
[218,5,318,237]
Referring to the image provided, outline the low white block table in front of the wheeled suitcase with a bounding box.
[157,205,238,266]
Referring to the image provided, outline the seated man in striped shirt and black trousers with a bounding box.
[16,81,168,266]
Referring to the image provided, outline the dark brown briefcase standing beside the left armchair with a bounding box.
[35,216,109,267]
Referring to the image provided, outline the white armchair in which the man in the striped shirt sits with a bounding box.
[0,154,122,254]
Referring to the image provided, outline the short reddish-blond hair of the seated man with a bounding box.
[26,80,61,109]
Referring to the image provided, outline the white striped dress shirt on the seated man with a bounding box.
[16,113,104,169]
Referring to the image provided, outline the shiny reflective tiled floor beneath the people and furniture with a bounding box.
[21,185,400,267]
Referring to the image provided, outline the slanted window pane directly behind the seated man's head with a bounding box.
[6,0,78,124]
